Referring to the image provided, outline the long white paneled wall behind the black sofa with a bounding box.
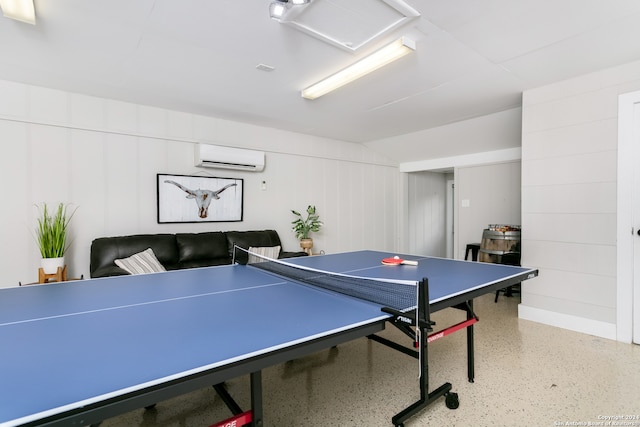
[0,81,403,287]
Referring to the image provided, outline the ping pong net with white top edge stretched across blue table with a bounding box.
[234,246,418,312]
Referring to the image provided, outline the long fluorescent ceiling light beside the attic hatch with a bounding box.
[301,37,416,99]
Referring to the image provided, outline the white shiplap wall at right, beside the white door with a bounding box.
[520,62,640,339]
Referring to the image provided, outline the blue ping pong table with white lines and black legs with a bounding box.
[0,251,537,427]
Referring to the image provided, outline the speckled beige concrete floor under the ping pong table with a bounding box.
[102,295,640,427]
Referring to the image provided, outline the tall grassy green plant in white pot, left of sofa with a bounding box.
[36,203,75,274]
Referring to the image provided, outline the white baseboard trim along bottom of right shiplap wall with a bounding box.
[518,304,616,340]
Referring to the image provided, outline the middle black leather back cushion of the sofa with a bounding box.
[176,231,229,264]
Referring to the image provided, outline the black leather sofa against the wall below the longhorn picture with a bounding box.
[89,230,307,278]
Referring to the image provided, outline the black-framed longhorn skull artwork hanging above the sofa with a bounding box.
[157,173,244,224]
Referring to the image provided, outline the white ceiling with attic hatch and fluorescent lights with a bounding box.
[0,0,640,159]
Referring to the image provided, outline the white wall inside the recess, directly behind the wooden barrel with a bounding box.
[454,161,524,259]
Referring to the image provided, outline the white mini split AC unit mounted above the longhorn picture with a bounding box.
[195,144,264,172]
